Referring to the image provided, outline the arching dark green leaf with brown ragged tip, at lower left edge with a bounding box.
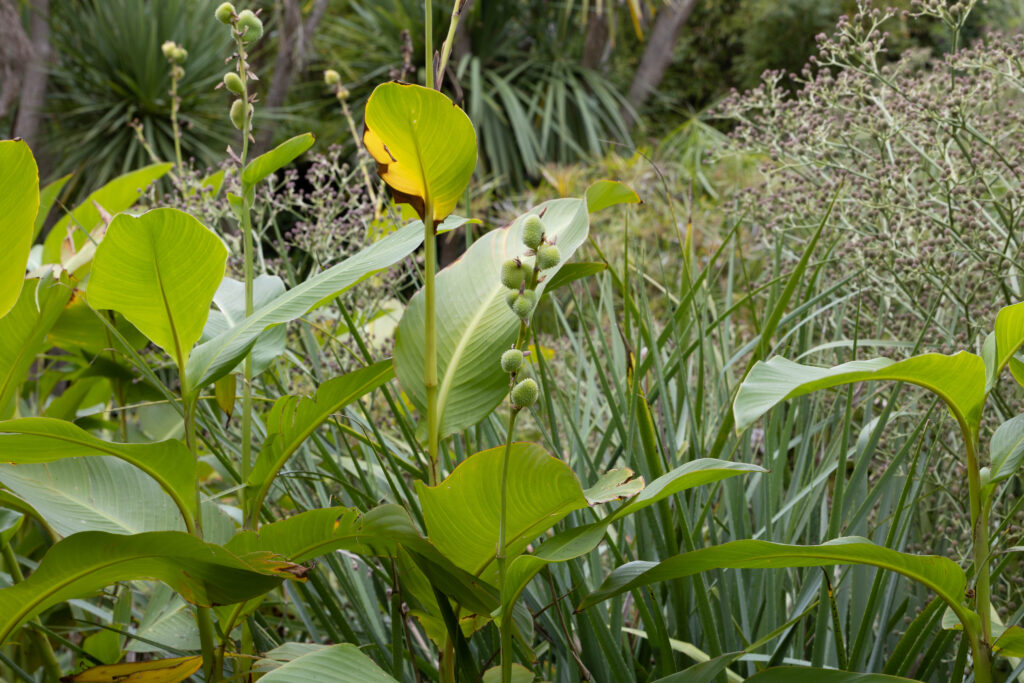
[0,531,295,643]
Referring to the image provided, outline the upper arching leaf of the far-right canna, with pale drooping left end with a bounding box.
[732,351,985,433]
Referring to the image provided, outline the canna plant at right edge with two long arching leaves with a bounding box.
[580,303,1024,683]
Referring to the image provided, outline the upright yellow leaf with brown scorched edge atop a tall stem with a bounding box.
[362,82,476,223]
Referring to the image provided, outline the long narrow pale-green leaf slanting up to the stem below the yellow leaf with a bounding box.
[185,217,466,391]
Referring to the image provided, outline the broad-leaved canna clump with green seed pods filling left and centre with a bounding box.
[0,2,763,683]
